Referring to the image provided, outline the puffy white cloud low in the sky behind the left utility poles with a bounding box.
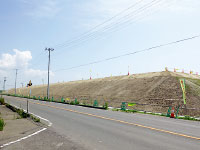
[0,49,54,86]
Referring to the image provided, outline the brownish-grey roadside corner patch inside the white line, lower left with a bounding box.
[0,105,43,145]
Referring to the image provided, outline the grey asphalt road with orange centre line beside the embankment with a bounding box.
[4,96,200,150]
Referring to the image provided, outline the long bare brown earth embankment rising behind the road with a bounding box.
[9,72,200,115]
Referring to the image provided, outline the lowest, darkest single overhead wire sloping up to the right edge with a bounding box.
[54,34,200,72]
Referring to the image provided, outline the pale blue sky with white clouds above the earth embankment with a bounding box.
[0,0,200,89]
